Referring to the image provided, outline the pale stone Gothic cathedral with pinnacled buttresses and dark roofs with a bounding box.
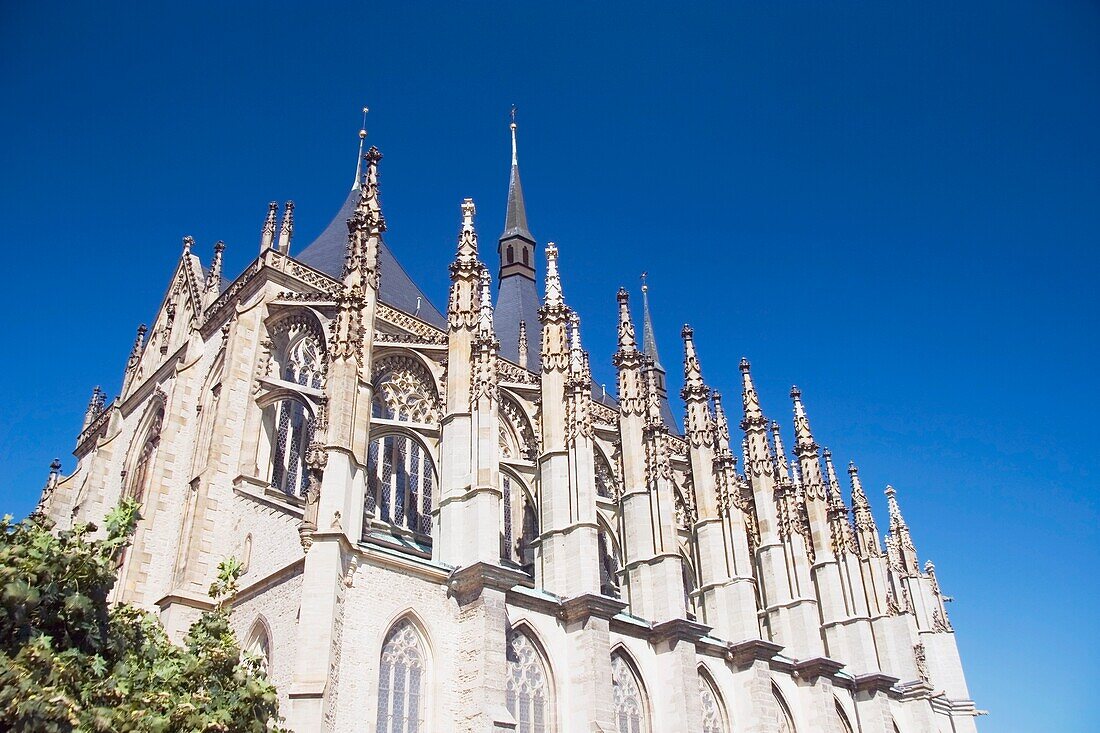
[40,115,979,733]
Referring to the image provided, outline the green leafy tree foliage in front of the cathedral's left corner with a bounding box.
[0,501,284,733]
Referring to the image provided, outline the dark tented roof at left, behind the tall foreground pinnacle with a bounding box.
[295,187,447,330]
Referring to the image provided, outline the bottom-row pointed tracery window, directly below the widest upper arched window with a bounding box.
[375,620,428,733]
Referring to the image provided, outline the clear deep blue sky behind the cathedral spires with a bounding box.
[0,2,1100,733]
